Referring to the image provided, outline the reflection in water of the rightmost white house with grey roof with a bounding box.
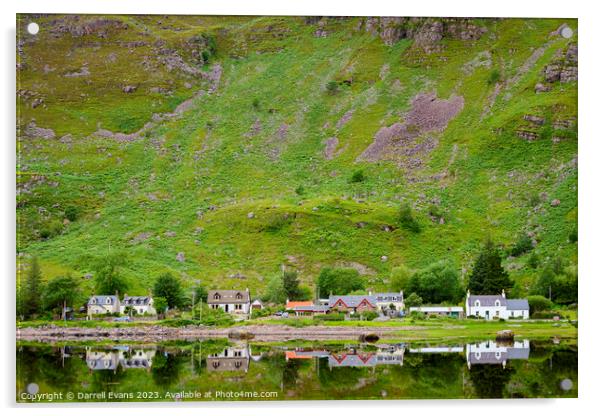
[466,340,529,368]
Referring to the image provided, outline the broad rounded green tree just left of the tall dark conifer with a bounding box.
[406,261,464,303]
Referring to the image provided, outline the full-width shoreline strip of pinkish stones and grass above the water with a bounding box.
[16,323,578,343]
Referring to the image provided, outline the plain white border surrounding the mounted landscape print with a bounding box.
[0,0,602,416]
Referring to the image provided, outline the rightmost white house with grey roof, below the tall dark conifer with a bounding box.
[466,290,529,320]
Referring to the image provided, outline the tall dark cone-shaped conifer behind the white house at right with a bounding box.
[468,240,513,295]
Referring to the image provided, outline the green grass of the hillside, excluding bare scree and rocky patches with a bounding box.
[18,17,577,293]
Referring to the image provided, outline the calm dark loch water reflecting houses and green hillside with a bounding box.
[17,340,577,403]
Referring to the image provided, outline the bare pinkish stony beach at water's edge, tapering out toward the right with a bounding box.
[17,325,425,342]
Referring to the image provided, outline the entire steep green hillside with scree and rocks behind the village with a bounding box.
[17,15,577,293]
